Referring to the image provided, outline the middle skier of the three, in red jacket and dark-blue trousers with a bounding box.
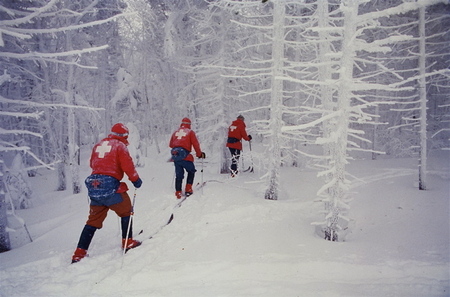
[169,118,206,199]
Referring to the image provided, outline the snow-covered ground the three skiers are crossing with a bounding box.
[0,146,450,297]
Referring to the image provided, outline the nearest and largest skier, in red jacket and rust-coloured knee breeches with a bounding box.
[72,123,142,263]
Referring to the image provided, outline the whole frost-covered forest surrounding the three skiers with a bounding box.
[0,0,450,293]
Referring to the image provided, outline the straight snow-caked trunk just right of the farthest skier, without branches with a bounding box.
[264,1,285,200]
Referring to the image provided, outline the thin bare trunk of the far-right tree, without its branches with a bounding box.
[419,7,427,190]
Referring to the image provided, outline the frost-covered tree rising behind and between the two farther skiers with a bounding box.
[175,5,236,173]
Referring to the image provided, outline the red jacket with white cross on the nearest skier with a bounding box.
[90,134,139,193]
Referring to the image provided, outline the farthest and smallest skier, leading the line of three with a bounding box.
[227,115,252,177]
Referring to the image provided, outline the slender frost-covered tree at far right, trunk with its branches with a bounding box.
[390,2,450,190]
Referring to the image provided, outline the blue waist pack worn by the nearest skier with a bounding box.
[84,174,120,200]
